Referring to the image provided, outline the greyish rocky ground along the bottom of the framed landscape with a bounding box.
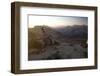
[29,43,87,60]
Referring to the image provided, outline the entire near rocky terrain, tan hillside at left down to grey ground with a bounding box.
[28,26,88,60]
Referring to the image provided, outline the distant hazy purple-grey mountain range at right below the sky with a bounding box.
[56,25,88,39]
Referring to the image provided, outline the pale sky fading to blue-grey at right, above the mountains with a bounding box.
[28,15,88,28]
